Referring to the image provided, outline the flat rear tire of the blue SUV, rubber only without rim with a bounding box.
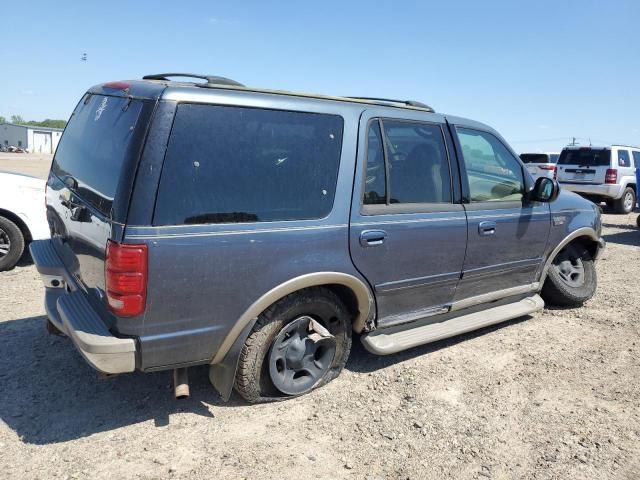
[234,287,352,403]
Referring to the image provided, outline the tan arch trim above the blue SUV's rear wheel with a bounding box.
[211,272,375,364]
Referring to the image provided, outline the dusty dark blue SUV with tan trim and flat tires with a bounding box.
[30,74,604,402]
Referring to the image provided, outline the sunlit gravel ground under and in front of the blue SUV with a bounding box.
[0,215,640,480]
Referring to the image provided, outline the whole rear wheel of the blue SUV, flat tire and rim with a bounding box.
[234,287,351,403]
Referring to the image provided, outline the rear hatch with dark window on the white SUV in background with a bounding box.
[558,147,611,185]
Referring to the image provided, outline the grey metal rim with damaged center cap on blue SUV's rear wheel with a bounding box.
[269,315,336,395]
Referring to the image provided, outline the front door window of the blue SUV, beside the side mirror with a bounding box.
[457,128,524,202]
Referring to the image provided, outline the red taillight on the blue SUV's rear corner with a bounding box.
[104,240,147,317]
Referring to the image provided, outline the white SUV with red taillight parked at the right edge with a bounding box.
[557,145,640,213]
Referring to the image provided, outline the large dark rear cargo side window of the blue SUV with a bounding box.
[154,104,343,225]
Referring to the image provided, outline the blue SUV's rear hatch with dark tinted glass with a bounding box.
[46,90,155,308]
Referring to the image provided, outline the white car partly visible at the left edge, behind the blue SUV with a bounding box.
[0,172,49,272]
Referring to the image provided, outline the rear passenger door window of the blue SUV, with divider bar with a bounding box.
[363,119,452,205]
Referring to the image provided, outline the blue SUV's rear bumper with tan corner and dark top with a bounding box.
[29,240,136,374]
